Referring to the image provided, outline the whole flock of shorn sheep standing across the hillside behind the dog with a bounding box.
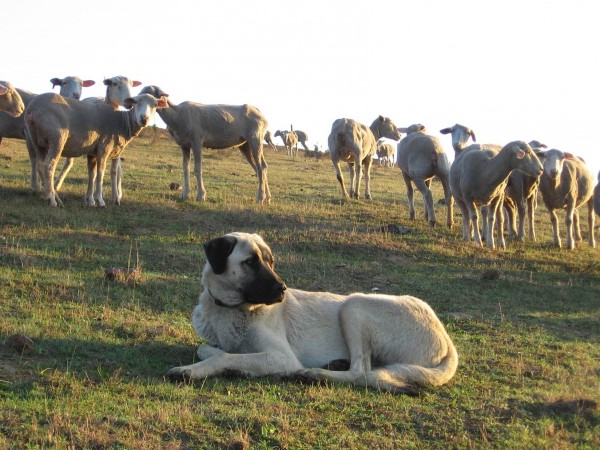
[0,76,600,253]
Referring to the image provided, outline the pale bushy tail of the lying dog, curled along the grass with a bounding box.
[366,338,458,393]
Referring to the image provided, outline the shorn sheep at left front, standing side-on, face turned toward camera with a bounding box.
[25,93,166,207]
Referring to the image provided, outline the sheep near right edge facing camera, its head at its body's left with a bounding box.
[540,149,596,250]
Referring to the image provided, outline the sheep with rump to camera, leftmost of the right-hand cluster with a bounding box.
[397,124,454,229]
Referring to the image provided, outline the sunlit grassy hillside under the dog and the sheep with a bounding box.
[0,135,600,449]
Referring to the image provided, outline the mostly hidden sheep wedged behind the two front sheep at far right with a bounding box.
[504,140,546,242]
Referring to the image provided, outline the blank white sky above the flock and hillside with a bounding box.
[0,0,600,178]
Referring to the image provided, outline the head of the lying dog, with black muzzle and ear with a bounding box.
[202,233,286,307]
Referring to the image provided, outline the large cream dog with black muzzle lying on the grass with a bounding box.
[167,233,458,393]
